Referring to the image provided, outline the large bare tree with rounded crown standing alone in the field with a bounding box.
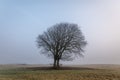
[37,23,87,68]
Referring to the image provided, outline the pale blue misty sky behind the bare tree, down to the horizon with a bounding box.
[0,0,120,64]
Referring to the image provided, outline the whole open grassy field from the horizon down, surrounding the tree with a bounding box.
[0,64,120,80]
